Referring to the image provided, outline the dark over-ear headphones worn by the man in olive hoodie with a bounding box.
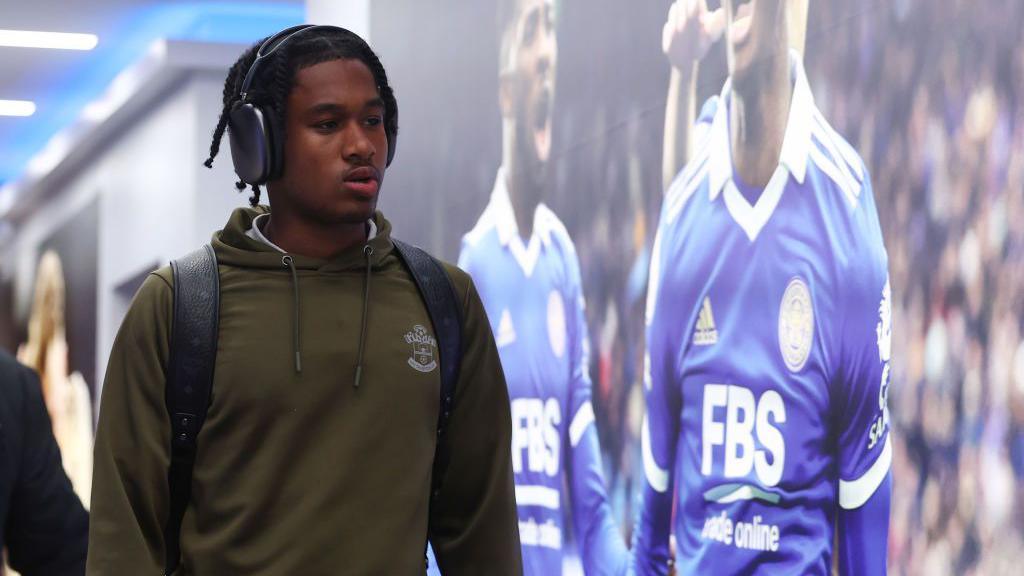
[227,24,397,184]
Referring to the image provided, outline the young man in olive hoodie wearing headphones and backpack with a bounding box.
[88,27,521,575]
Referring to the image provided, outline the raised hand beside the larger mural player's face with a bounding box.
[662,0,725,70]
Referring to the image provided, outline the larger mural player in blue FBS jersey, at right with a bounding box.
[635,0,892,575]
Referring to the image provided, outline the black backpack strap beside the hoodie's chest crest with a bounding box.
[391,238,462,500]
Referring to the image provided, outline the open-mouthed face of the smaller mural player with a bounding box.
[502,0,558,170]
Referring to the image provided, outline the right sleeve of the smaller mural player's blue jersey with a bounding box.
[565,235,630,575]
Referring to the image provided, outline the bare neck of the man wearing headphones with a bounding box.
[262,212,368,260]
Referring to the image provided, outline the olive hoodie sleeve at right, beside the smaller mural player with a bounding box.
[430,266,522,575]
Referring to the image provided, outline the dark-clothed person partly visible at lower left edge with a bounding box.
[0,351,89,576]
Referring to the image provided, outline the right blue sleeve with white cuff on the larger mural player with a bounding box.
[837,169,892,506]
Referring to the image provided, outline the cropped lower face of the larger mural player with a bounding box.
[723,0,786,82]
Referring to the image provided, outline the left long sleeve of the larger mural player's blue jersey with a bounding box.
[633,225,682,574]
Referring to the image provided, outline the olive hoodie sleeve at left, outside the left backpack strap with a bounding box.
[87,269,173,576]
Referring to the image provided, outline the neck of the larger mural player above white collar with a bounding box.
[729,48,793,188]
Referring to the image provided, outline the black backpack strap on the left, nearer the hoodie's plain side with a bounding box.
[164,244,220,575]
